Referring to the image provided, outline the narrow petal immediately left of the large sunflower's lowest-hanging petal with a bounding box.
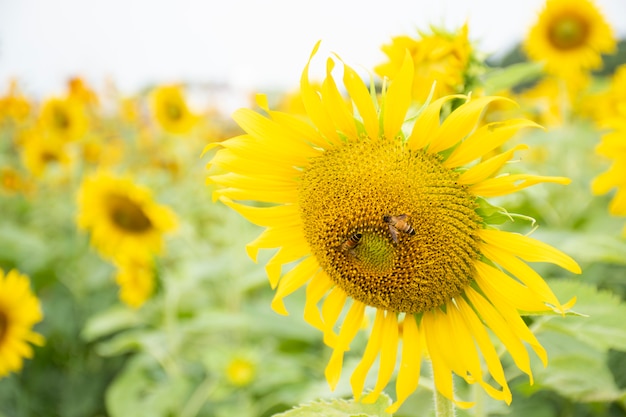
[363,311,398,404]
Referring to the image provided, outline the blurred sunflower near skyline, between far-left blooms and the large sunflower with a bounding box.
[152,85,199,134]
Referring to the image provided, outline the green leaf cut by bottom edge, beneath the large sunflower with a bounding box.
[274,393,391,417]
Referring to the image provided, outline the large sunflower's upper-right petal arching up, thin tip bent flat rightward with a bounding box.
[428,96,514,153]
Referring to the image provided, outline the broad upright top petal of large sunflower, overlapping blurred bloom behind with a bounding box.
[383,51,414,139]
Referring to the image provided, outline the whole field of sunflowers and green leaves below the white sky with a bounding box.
[0,0,626,417]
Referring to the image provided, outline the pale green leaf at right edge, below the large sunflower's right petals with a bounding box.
[543,280,626,351]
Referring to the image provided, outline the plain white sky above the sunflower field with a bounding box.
[0,0,626,95]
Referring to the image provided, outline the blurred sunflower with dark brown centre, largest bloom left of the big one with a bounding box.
[77,172,177,261]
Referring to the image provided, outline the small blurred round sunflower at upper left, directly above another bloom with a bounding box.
[39,98,89,142]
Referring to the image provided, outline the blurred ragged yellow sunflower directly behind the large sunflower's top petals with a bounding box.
[374,24,473,103]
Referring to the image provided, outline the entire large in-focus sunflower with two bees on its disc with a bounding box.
[207,46,580,412]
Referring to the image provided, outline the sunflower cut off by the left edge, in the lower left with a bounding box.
[0,269,44,378]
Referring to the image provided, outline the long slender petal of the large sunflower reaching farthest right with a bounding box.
[478,229,581,274]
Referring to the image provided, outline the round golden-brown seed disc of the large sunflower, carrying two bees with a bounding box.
[299,137,481,313]
